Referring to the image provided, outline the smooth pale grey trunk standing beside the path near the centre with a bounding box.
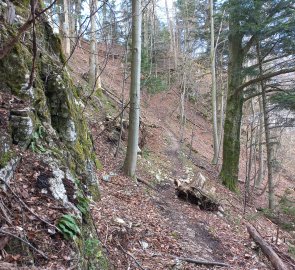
[124,0,142,177]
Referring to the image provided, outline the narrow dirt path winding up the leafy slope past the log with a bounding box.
[145,106,228,269]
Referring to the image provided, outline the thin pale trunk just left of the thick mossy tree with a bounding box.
[209,0,219,165]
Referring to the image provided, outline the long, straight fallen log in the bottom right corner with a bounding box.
[247,224,289,270]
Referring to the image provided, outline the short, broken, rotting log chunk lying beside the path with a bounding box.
[174,180,220,211]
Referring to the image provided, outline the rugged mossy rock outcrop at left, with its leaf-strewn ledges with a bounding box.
[0,0,105,269]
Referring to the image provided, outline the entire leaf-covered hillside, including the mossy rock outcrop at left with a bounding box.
[0,0,295,270]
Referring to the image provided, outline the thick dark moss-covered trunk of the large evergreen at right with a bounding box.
[220,10,244,191]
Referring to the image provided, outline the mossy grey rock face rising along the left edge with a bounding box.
[0,0,108,269]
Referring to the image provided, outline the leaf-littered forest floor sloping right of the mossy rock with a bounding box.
[71,42,291,270]
